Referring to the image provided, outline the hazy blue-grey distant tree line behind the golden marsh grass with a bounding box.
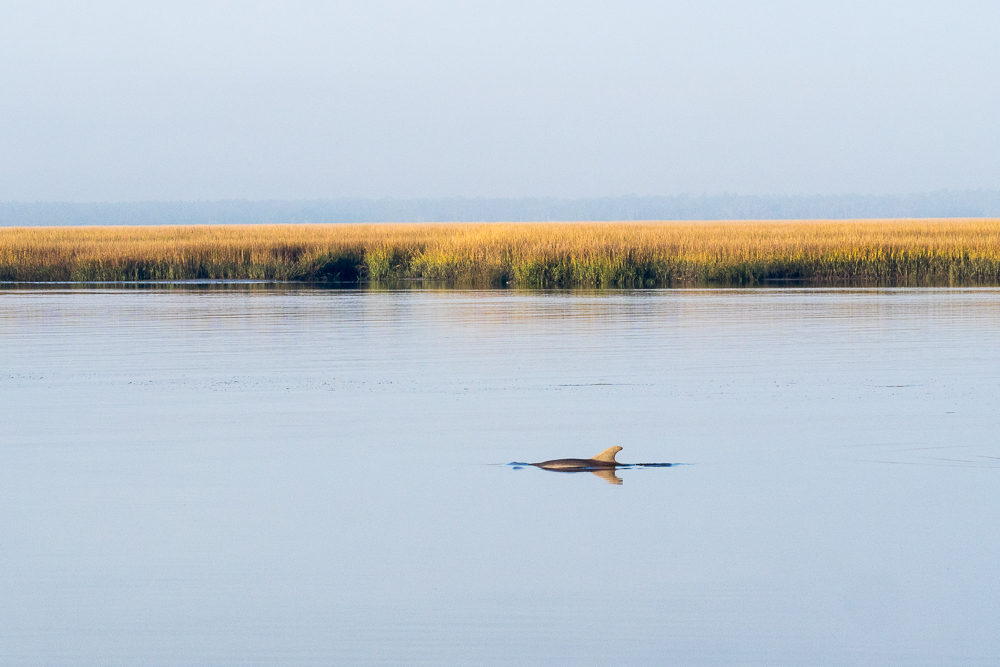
[0,190,1000,227]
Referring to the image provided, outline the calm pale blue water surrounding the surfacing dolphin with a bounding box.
[0,286,1000,666]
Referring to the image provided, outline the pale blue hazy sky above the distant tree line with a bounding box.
[0,0,1000,201]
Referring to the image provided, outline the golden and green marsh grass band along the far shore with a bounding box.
[0,220,1000,287]
